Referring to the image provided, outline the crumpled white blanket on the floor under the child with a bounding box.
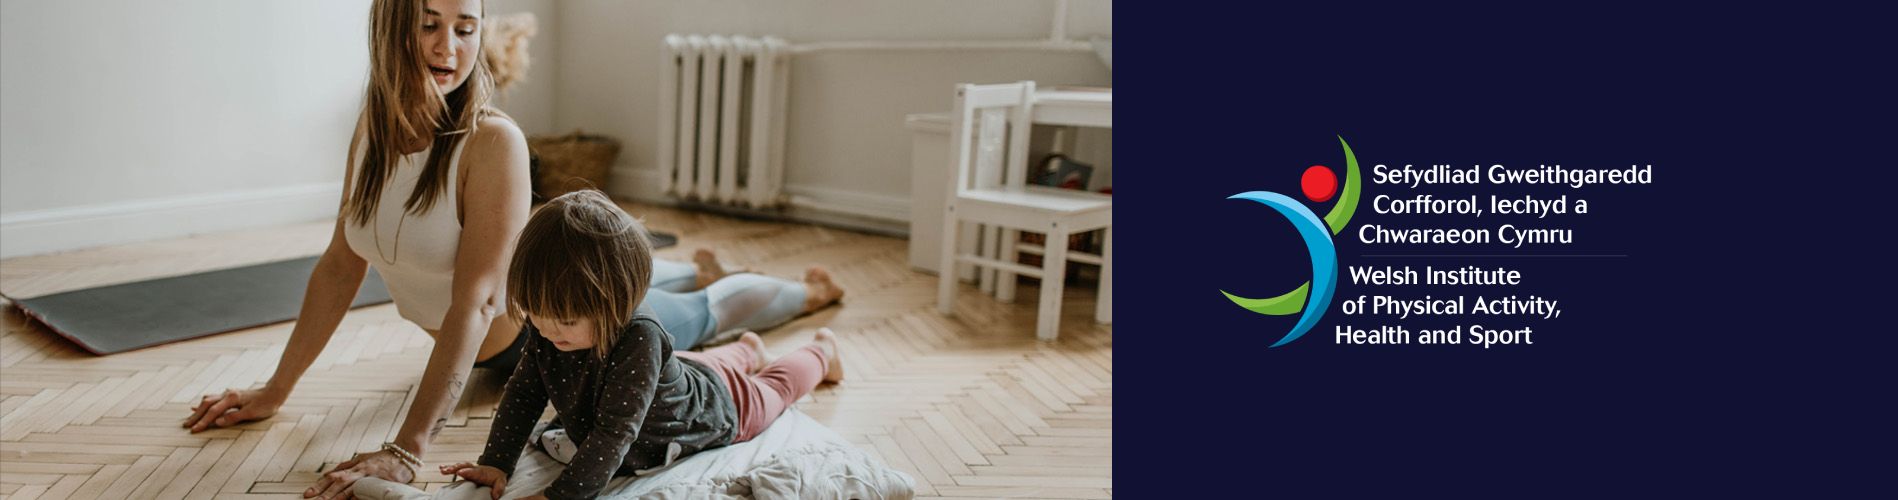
[355,409,915,500]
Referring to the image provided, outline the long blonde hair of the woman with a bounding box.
[344,0,497,226]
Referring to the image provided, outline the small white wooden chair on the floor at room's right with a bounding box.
[936,82,1114,340]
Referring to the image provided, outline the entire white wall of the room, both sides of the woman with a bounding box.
[0,0,1112,257]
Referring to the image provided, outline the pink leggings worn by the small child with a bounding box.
[672,342,829,445]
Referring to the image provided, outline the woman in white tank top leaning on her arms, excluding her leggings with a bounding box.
[184,0,835,498]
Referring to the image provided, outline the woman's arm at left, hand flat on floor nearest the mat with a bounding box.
[184,124,368,432]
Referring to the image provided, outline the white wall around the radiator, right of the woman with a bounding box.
[556,0,1112,229]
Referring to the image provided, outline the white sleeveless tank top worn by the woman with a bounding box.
[344,141,467,331]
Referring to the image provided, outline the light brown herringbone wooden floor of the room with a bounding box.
[0,203,1114,498]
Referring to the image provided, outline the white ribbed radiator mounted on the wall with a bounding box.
[659,34,790,207]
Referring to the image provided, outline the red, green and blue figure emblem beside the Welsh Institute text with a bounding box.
[1219,137,1361,348]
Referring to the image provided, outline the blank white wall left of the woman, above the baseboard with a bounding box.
[0,0,368,257]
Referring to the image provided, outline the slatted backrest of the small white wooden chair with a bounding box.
[949,82,1034,198]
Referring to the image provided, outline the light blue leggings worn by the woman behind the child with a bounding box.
[645,259,805,350]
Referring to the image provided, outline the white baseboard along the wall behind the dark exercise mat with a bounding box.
[0,183,342,259]
